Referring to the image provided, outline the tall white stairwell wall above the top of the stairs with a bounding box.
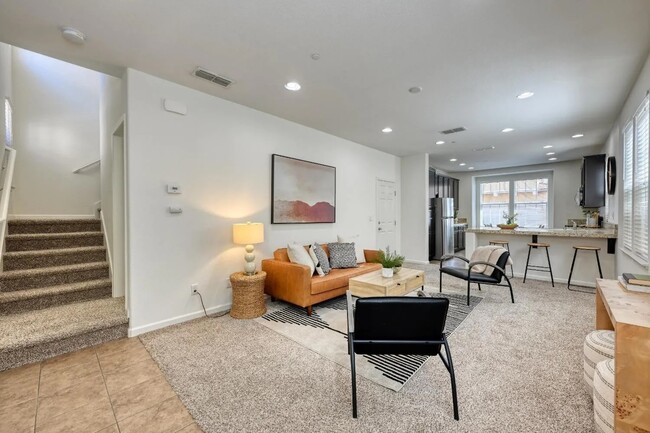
[11,48,100,216]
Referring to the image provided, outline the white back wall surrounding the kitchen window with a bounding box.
[450,160,584,228]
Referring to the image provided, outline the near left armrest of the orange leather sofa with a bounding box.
[262,259,311,307]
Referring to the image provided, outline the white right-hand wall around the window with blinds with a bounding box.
[602,50,650,275]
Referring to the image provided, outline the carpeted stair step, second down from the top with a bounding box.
[5,232,104,252]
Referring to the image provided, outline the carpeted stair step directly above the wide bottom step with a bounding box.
[0,278,112,314]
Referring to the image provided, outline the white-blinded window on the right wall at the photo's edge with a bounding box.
[619,94,650,267]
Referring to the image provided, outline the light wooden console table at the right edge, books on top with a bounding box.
[596,280,650,433]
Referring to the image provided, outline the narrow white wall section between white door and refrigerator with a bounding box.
[401,153,429,263]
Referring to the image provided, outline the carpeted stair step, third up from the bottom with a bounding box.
[0,261,109,292]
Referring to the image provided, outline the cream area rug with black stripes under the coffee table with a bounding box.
[255,290,483,391]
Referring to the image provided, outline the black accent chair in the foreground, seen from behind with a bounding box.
[347,290,458,421]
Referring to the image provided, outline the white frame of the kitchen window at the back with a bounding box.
[472,170,555,228]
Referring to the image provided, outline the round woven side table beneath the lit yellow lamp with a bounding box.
[230,271,266,319]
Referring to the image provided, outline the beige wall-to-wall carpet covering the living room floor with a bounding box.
[141,266,594,433]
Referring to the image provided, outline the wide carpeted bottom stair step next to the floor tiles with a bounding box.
[0,298,129,371]
